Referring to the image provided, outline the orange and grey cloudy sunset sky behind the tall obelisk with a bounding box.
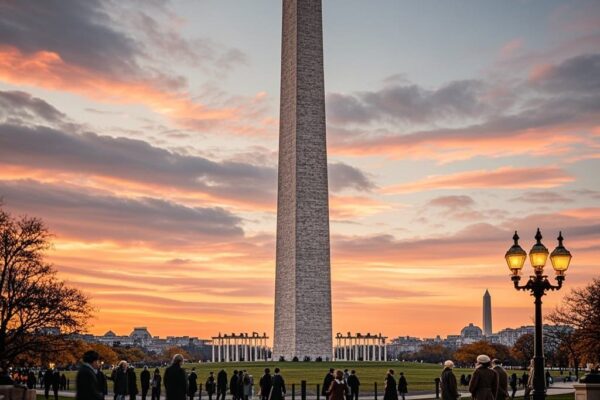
[0,0,600,337]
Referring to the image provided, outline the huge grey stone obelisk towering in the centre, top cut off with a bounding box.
[273,0,332,361]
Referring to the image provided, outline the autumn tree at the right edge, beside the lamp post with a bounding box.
[548,278,600,364]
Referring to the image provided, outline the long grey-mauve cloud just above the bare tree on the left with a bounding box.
[0,180,243,246]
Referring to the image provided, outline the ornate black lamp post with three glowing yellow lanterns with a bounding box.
[505,228,571,400]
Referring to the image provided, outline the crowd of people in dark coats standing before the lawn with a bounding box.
[69,351,564,400]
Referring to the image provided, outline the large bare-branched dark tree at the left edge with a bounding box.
[0,203,91,362]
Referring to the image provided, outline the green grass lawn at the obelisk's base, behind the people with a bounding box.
[56,361,562,392]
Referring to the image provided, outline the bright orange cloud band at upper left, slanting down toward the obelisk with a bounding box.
[0,46,238,125]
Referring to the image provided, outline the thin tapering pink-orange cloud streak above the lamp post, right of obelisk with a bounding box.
[382,163,575,194]
